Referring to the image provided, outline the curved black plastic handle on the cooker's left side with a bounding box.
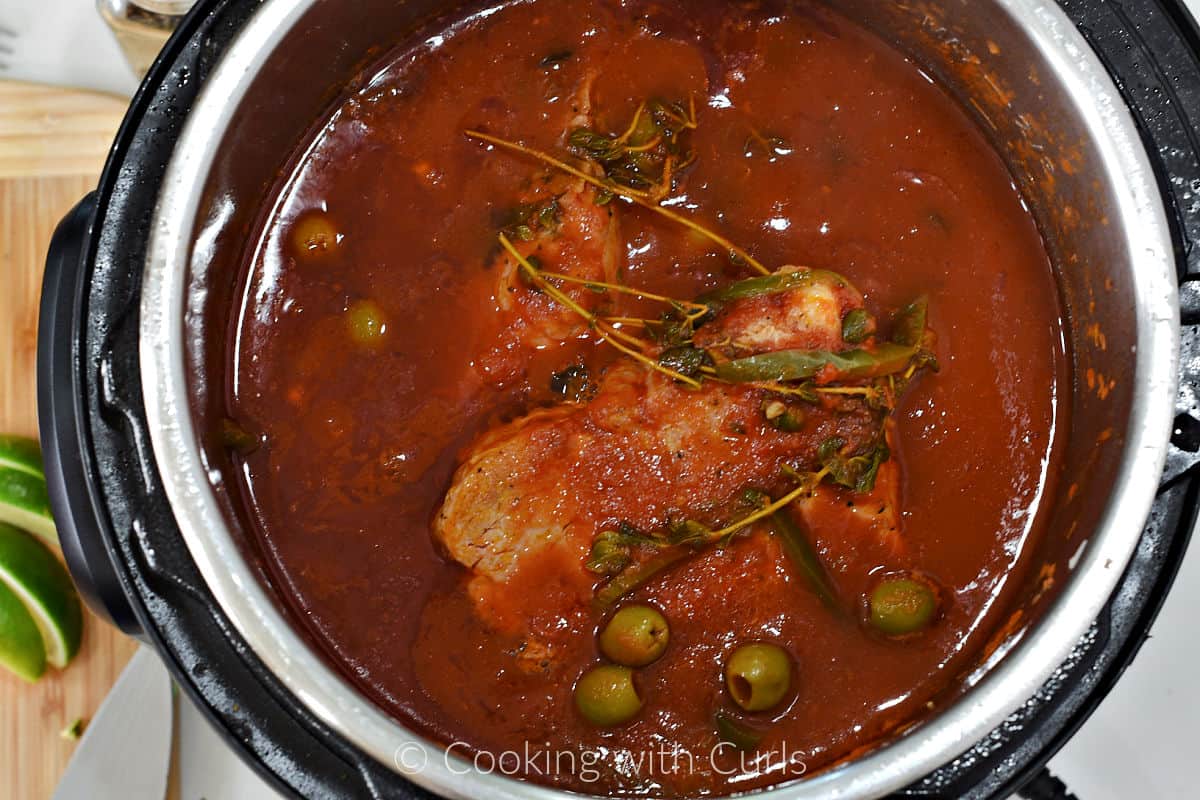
[37,192,142,636]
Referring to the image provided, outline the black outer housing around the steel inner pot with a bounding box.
[38,0,1200,800]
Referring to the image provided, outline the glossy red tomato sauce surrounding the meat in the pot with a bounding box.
[228,0,1070,796]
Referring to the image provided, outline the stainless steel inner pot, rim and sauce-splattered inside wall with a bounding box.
[140,0,1178,800]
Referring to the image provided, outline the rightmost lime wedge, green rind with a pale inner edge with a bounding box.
[0,524,83,669]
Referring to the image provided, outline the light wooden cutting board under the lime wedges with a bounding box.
[0,82,137,800]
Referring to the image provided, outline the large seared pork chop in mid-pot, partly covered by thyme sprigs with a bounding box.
[434,267,900,652]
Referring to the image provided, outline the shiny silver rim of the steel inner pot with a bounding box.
[139,0,1180,800]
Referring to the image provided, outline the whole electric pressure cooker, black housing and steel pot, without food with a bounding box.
[38,0,1200,800]
